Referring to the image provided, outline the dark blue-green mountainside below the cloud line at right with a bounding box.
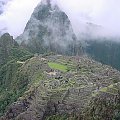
[85,40,120,70]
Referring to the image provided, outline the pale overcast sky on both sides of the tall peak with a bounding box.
[0,0,120,37]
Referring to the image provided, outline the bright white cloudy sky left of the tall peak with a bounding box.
[0,0,40,37]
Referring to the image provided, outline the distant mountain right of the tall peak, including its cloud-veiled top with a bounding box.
[79,23,120,70]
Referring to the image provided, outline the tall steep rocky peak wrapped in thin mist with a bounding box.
[17,0,81,55]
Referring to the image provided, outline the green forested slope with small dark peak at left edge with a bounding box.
[0,33,33,115]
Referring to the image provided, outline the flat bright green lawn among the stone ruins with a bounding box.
[48,62,68,72]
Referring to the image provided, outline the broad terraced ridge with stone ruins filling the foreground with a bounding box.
[1,55,120,120]
